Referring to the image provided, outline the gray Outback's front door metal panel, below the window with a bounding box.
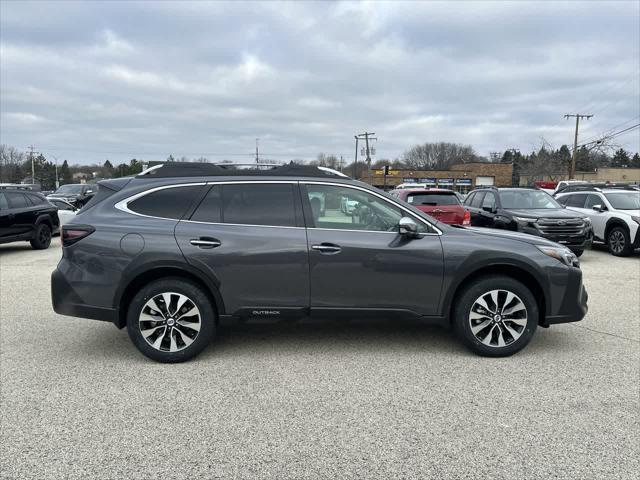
[307,228,443,315]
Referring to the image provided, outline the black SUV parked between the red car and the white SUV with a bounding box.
[464,187,593,257]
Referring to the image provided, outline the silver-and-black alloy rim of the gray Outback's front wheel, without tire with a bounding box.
[469,290,527,347]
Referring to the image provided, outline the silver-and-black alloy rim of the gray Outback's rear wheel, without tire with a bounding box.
[138,292,202,352]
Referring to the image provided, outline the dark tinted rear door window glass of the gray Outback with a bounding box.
[222,183,296,227]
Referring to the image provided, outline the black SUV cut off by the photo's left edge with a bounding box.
[0,188,60,250]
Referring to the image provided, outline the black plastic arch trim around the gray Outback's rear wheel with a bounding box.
[113,259,226,328]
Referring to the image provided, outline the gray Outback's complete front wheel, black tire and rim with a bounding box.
[453,275,539,357]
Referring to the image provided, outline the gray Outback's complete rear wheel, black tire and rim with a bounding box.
[127,277,216,363]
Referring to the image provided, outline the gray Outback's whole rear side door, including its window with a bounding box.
[175,182,309,317]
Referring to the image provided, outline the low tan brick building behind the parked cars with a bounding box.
[360,162,513,193]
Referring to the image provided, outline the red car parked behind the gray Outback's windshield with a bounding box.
[390,188,471,225]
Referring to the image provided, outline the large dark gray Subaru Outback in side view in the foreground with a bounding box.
[51,163,587,362]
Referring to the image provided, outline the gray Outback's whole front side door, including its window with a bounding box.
[301,182,443,315]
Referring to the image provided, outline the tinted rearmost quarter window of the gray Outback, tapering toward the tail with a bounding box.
[127,185,202,220]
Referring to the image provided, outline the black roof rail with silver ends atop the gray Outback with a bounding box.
[137,162,349,178]
